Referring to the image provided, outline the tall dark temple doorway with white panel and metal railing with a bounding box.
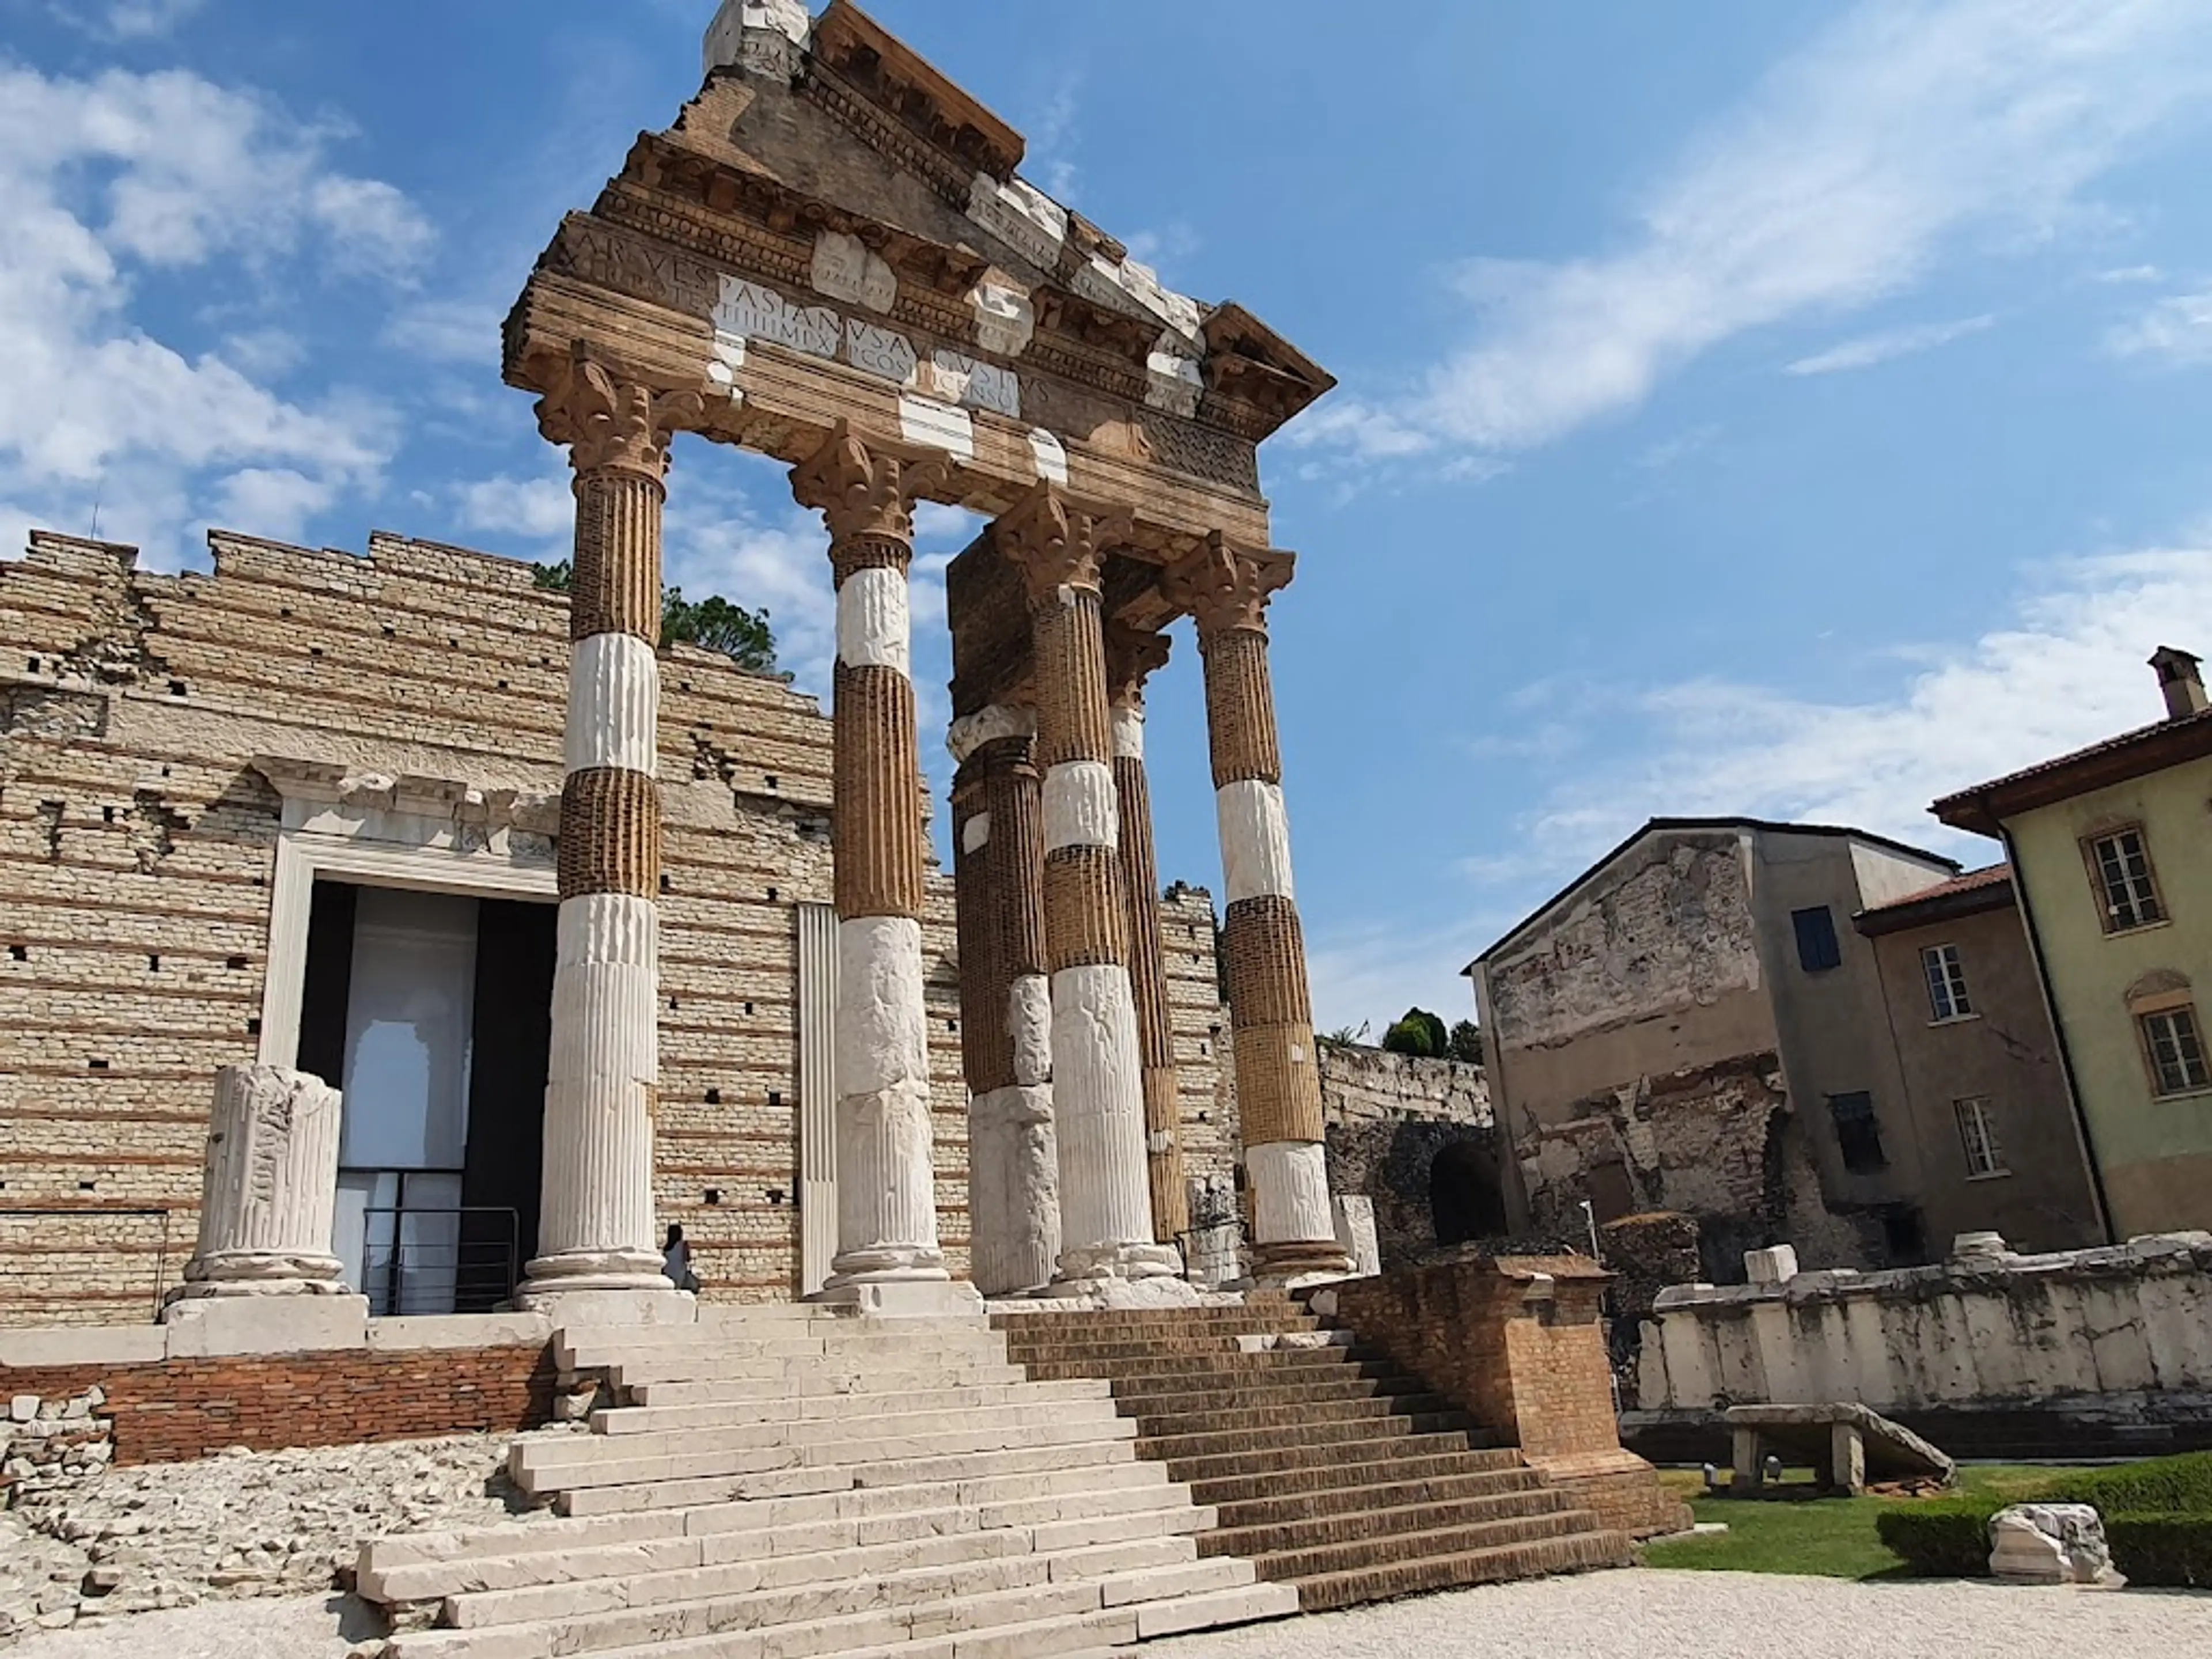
[298,878,555,1316]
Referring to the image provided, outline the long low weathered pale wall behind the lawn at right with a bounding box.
[1637,1232,2212,1411]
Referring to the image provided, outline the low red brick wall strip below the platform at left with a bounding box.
[0,1347,558,1464]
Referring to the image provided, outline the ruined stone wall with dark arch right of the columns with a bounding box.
[1319,1042,1506,1267]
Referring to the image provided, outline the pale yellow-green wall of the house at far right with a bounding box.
[2006,759,2212,1238]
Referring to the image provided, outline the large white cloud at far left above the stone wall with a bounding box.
[0,66,429,562]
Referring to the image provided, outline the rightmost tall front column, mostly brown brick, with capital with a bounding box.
[1164,533,1349,1279]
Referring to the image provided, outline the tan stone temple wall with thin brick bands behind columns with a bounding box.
[0,533,982,1325]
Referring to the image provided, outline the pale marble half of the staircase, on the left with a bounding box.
[356,1307,1298,1659]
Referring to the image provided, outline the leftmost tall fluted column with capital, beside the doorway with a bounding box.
[518,347,701,1320]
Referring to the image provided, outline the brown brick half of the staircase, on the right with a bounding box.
[993,1292,1630,1612]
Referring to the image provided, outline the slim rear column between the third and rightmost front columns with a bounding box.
[1106,624,1190,1243]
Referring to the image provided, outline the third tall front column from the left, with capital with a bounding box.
[995,484,1179,1281]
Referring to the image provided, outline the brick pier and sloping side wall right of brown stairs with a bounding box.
[1330,1256,1688,1535]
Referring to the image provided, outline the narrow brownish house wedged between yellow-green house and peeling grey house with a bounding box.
[1854,865,2106,1250]
